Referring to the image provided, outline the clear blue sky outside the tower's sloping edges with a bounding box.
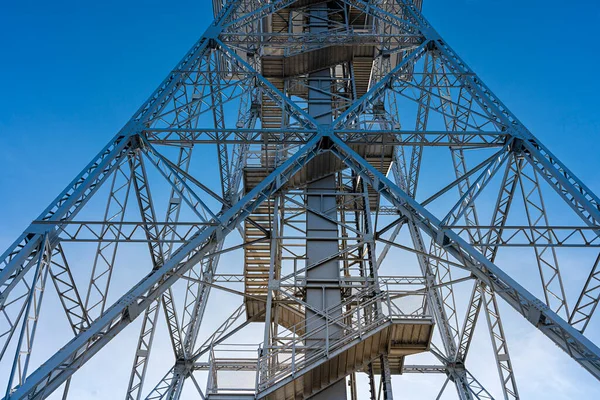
[0,0,600,399]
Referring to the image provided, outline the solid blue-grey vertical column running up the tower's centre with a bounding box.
[305,3,346,400]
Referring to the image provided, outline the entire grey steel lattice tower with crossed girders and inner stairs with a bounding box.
[0,0,600,400]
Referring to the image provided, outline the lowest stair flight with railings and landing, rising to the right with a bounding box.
[256,292,433,400]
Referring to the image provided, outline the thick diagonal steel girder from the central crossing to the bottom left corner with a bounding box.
[6,137,321,399]
